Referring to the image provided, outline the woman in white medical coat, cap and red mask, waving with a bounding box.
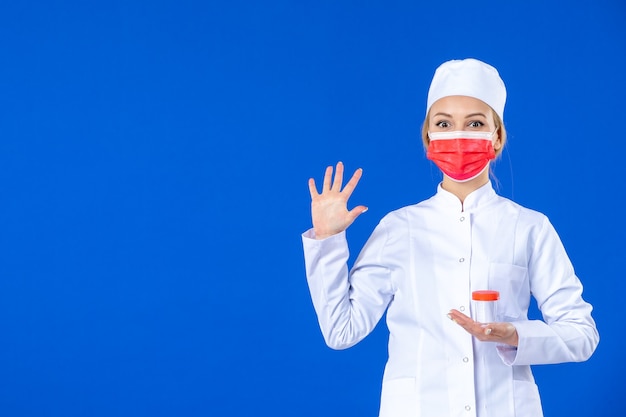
[302,59,599,417]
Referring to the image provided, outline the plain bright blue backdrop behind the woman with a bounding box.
[0,0,626,417]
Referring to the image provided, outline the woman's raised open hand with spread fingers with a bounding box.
[309,162,367,239]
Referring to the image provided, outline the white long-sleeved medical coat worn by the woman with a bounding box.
[302,183,599,417]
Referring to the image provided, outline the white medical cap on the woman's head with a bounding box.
[426,58,506,120]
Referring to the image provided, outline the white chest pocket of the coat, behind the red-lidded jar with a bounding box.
[489,263,530,322]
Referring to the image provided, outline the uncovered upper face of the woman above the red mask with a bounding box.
[428,96,502,150]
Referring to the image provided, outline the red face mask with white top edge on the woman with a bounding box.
[426,131,496,182]
